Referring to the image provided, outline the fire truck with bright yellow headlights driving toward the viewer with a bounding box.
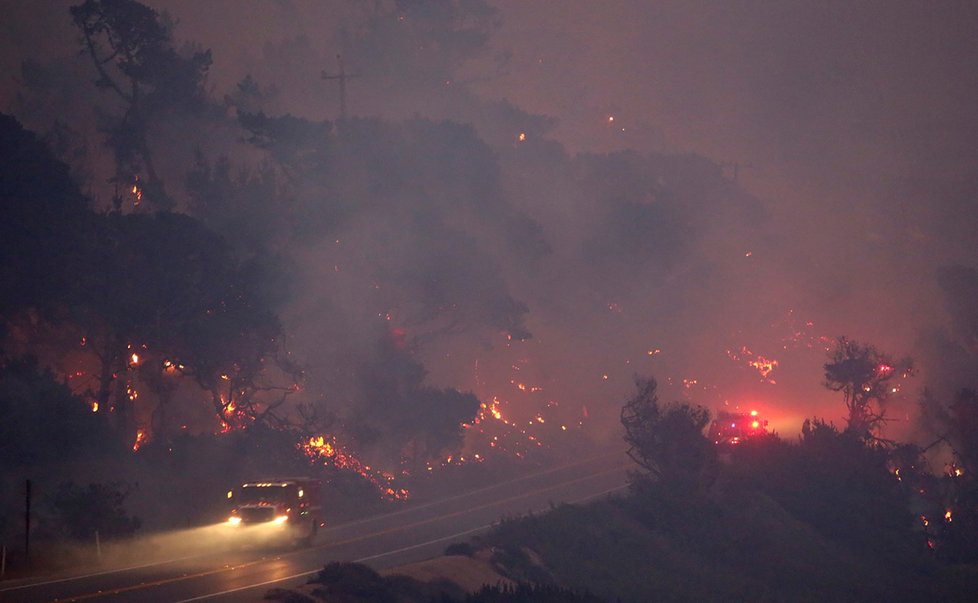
[228,477,325,545]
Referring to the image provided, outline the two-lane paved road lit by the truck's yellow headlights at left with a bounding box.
[0,453,628,603]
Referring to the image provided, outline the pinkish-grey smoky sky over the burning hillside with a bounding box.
[0,0,978,444]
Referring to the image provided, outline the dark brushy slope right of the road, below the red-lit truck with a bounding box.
[481,376,978,601]
